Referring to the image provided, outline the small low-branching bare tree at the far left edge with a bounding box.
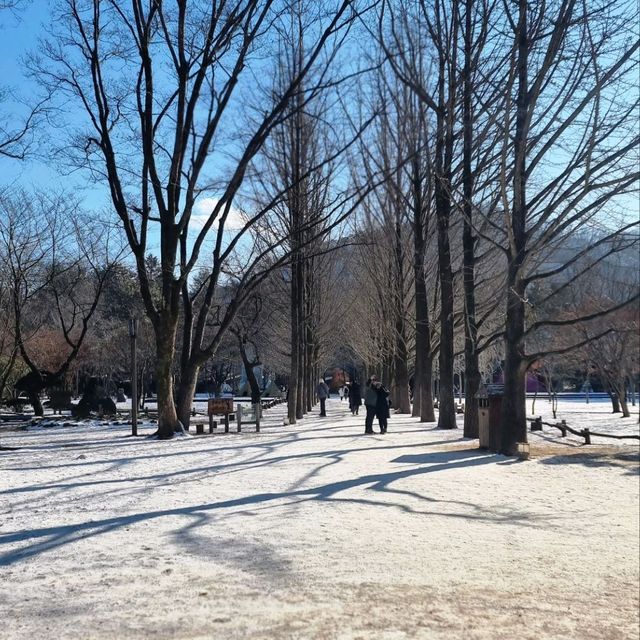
[0,188,120,415]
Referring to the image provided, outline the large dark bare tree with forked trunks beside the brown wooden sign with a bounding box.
[35,0,376,437]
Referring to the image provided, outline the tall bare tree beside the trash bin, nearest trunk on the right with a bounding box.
[501,0,640,454]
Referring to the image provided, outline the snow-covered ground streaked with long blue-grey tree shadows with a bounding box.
[0,398,640,640]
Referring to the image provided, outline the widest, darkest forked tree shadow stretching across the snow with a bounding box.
[0,449,541,566]
